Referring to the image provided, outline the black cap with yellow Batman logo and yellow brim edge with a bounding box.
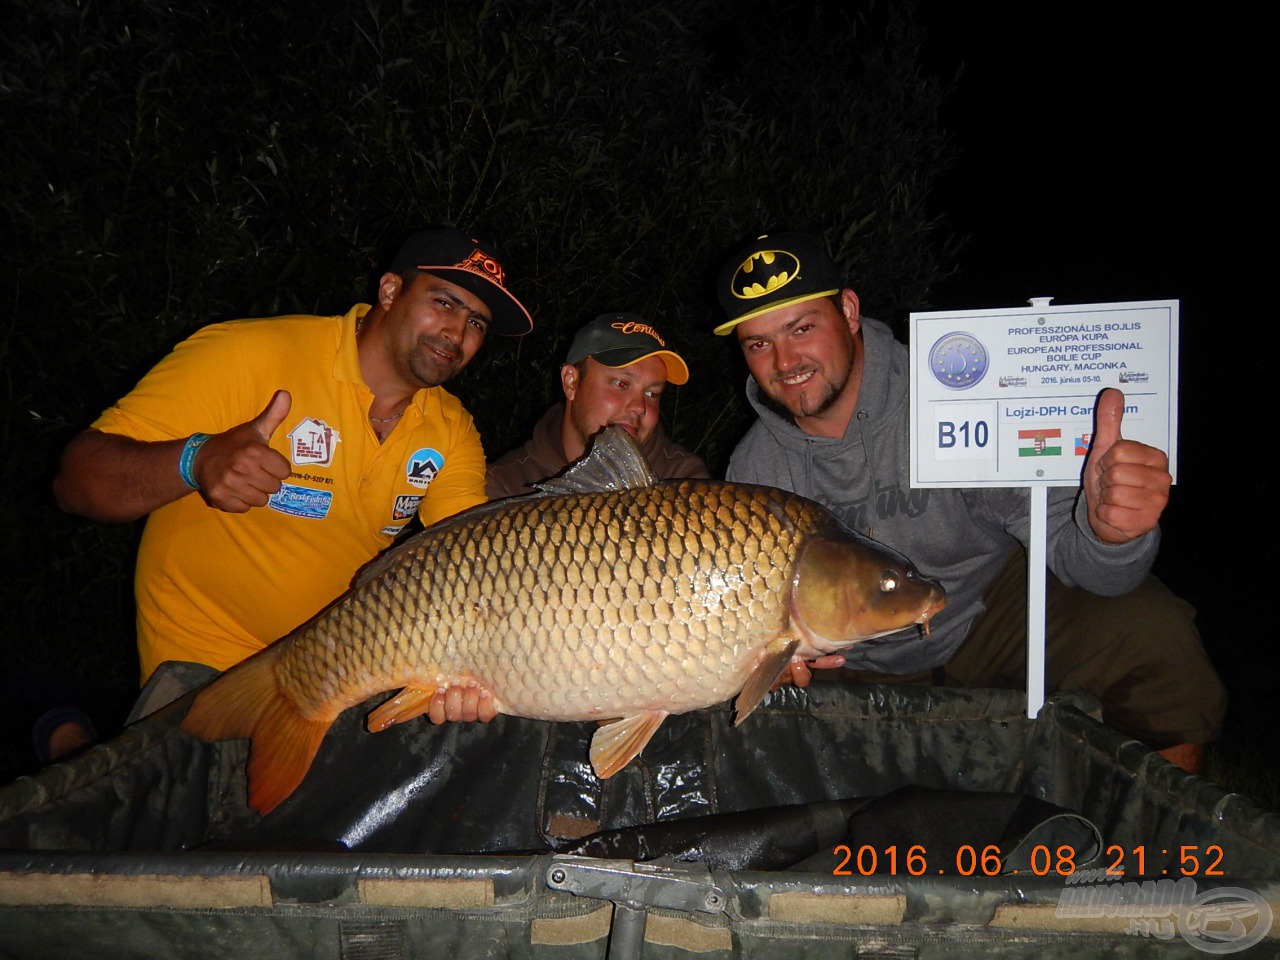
[716,233,844,337]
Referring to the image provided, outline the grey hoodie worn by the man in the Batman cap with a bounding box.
[727,317,1160,673]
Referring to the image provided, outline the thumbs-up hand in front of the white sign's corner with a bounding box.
[1080,388,1172,544]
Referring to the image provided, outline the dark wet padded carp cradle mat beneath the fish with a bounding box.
[0,684,1280,960]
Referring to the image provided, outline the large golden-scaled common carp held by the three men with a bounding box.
[183,428,943,813]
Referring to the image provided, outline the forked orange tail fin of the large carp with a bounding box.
[182,645,333,813]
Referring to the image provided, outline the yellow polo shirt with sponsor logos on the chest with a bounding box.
[93,303,485,682]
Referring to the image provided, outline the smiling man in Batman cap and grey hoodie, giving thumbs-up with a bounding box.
[716,233,1226,771]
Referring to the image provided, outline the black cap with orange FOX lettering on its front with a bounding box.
[387,227,534,337]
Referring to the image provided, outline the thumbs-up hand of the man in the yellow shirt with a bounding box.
[192,390,293,513]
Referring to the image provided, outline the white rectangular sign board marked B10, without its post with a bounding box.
[910,300,1178,486]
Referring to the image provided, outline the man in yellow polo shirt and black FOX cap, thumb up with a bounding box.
[54,229,532,719]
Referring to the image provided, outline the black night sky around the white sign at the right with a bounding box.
[925,4,1264,722]
